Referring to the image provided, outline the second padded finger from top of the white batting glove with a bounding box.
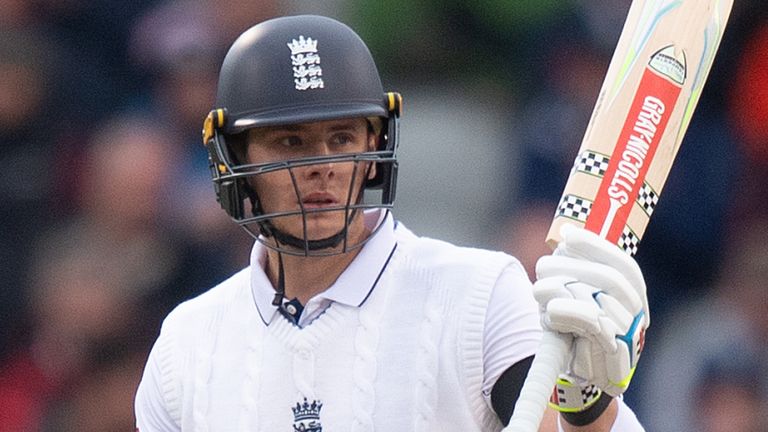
[536,255,645,313]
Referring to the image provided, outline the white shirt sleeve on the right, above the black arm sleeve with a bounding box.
[483,261,542,406]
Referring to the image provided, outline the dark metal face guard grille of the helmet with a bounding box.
[204,105,399,256]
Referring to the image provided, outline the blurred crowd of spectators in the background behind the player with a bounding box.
[0,0,768,432]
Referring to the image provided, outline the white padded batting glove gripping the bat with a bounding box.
[533,224,650,396]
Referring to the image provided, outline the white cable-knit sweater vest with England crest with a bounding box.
[149,230,511,432]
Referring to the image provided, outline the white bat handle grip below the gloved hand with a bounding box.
[502,331,573,432]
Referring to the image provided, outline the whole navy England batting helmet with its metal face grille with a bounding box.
[203,16,402,256]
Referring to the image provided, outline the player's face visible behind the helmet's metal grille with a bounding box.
[246,118,376,246]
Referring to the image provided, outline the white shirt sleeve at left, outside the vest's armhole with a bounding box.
[134,336,181,432]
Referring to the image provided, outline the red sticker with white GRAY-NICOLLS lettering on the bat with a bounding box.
[585,68,681,243]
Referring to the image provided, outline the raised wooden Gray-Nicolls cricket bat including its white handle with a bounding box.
[504,0,733,432]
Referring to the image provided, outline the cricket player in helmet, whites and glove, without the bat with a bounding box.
[135,16,649,432]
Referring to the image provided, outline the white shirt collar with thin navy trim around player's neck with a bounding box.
[251,210,396,325]
